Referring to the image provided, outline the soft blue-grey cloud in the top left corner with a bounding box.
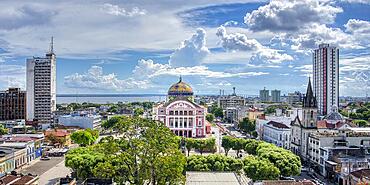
[0,5,57,30]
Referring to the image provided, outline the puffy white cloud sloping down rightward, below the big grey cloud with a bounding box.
[216,26,293,63]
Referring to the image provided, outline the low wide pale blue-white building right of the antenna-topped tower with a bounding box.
[59,114,101,129]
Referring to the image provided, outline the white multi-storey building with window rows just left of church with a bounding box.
[263,121,290,149]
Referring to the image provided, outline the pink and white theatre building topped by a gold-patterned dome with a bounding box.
[152,77,210,137]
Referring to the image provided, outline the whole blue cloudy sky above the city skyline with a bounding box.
[0,0,370,96]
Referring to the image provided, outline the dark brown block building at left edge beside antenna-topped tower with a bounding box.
[0,88,26,120]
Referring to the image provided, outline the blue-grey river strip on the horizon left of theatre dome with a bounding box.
[57,94,166,104]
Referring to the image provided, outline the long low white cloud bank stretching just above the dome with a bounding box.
[64,59,269,92]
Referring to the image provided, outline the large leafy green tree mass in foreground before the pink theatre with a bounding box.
[65,117,186,184]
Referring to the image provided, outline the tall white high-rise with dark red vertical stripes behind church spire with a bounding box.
[313,44,339,115]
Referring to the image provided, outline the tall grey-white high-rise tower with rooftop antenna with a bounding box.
[27,38,56,125]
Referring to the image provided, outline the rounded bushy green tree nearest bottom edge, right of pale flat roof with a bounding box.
[243,156,280,181]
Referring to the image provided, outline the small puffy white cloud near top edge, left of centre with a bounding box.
[102,3,147,17]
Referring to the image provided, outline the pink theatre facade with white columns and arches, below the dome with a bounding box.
[154,99,207,137]
